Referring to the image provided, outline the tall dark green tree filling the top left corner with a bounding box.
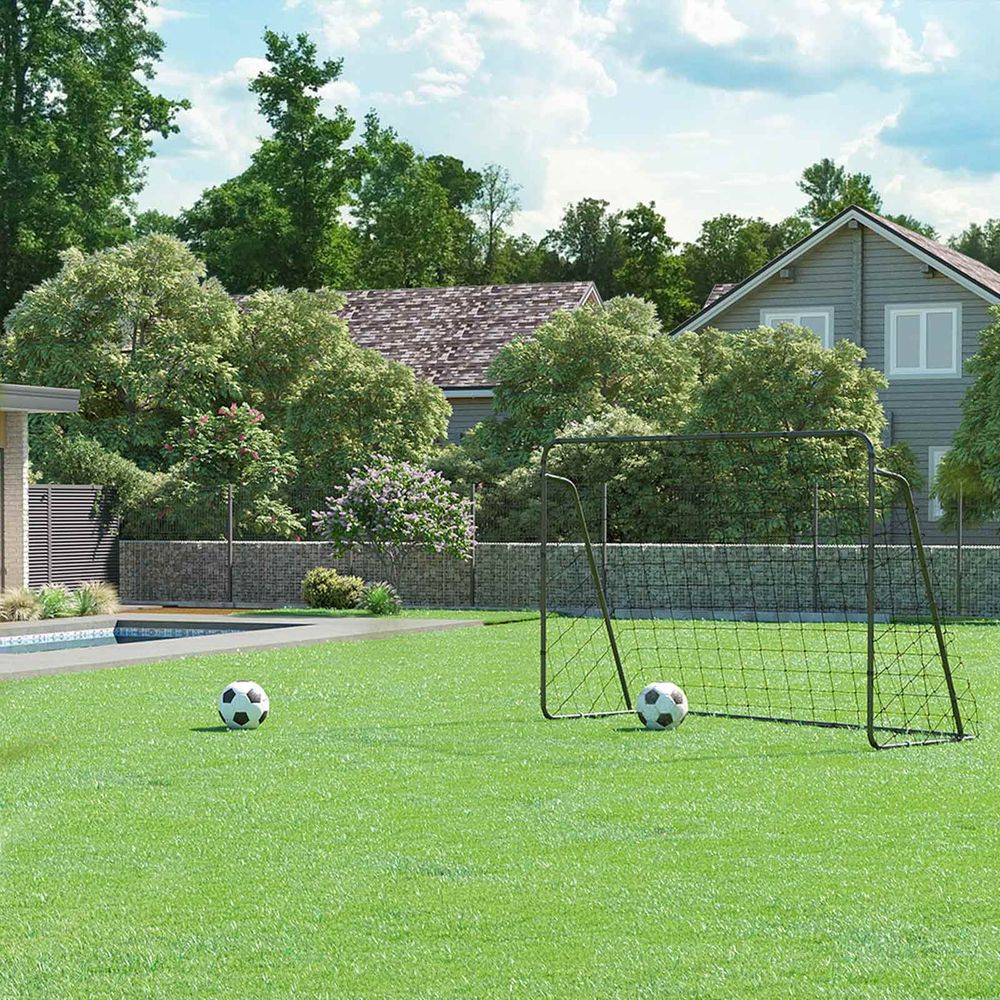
[0,0,187,317]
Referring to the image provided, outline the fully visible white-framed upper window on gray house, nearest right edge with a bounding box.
[885,305,962,376]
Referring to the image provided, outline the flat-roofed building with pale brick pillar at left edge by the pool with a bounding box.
[0,383,80,589]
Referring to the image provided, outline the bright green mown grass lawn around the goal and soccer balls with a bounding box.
[0,622,1000,1000]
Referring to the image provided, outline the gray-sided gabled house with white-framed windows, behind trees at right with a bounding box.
[672,207,1000,542]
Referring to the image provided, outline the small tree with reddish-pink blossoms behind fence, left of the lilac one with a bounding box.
[164,403,305,537]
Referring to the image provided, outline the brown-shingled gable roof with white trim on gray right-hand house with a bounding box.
[670,205,1000,334]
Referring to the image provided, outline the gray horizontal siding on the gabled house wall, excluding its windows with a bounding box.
[692,225,998,543]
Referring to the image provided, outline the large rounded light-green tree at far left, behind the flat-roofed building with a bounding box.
[2,234,237,470]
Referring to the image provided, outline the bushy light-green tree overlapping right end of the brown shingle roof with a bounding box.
[476,298,695,458]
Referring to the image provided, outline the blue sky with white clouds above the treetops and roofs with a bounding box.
[140,0,1000,239]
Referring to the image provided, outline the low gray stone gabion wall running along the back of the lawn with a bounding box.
[120,541,1000,617]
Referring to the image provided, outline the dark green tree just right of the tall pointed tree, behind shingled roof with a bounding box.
[353,112,465,288]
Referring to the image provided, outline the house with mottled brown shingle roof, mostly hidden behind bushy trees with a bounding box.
[341,281,601,441]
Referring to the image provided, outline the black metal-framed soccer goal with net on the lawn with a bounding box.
[540,431,975,748]
